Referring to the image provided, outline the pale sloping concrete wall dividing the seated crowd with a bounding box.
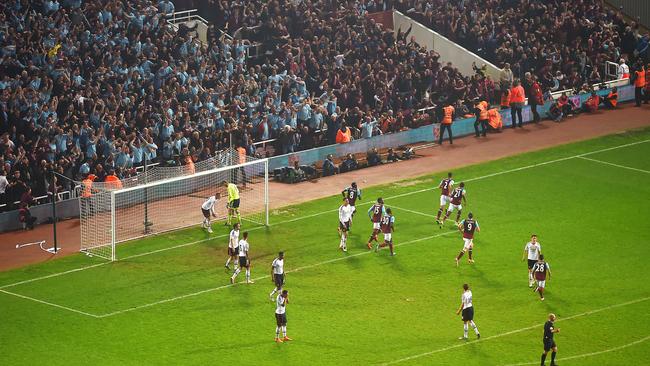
[393,10,501,80]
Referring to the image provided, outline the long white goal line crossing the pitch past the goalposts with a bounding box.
[0,139,650,289]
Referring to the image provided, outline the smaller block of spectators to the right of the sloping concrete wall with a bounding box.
[390,0,650,91]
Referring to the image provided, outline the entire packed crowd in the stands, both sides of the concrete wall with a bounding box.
[0,0,647,212]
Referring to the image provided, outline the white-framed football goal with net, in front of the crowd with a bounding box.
[79,159,269,261]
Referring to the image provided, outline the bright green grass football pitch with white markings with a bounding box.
[0,129,650,365]
